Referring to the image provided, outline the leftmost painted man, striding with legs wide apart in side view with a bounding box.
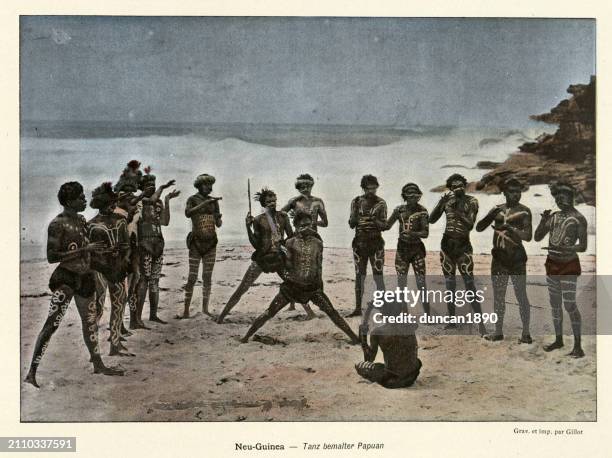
[25,181,124,388]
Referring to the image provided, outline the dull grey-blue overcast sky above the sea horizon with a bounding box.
[21,16,595,126]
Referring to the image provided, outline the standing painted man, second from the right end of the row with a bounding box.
[476,178,533,344]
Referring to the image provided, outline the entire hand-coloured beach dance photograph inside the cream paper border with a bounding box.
[19,16,592,422]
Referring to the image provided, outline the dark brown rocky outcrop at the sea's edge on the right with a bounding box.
[432,76,595,205]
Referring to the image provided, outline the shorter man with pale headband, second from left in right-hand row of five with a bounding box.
[387,183,430,315]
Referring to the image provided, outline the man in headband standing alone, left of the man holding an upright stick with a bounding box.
[177,173,223,319]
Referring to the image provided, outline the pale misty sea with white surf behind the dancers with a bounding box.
[20,122,595,259]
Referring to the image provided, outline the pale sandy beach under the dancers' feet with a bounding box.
[21,246,597,422]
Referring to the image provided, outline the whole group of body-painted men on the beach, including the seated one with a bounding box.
[26,160,587,388]
